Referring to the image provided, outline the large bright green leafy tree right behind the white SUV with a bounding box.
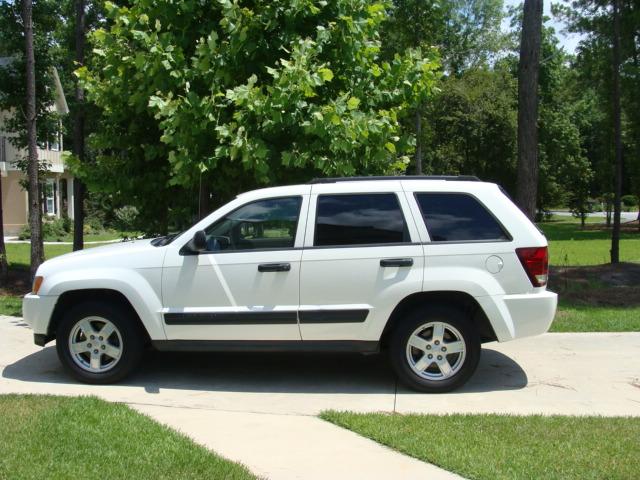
[79,0,439,229]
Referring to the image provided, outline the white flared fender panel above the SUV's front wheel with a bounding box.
[41,268,167,340]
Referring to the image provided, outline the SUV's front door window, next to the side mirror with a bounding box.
[205,197,302,252]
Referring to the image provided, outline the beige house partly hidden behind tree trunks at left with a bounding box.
[0,58,73,236]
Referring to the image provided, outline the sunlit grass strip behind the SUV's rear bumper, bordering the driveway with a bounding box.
[550,300,640,332]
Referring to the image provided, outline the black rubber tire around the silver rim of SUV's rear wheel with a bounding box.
[389,306,482,393]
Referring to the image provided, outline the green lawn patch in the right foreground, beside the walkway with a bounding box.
[321,411,640,480]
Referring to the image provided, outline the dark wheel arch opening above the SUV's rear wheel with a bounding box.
[380,290,498,347]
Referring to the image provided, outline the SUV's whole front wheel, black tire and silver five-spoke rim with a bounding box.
[56,302,144,383]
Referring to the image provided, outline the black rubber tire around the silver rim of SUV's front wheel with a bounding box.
[56,302,144,384]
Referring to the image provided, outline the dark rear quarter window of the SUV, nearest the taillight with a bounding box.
[416,193,511,242]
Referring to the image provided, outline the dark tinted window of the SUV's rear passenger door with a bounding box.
[314,193,409,246]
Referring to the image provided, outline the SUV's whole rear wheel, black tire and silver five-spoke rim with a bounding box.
[390,306,481,393]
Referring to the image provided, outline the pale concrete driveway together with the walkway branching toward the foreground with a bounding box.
[0,317,640,479]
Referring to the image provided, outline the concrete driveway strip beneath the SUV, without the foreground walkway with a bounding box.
[0,317,640,416]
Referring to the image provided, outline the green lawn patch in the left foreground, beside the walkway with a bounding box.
[0,395,255,480]
